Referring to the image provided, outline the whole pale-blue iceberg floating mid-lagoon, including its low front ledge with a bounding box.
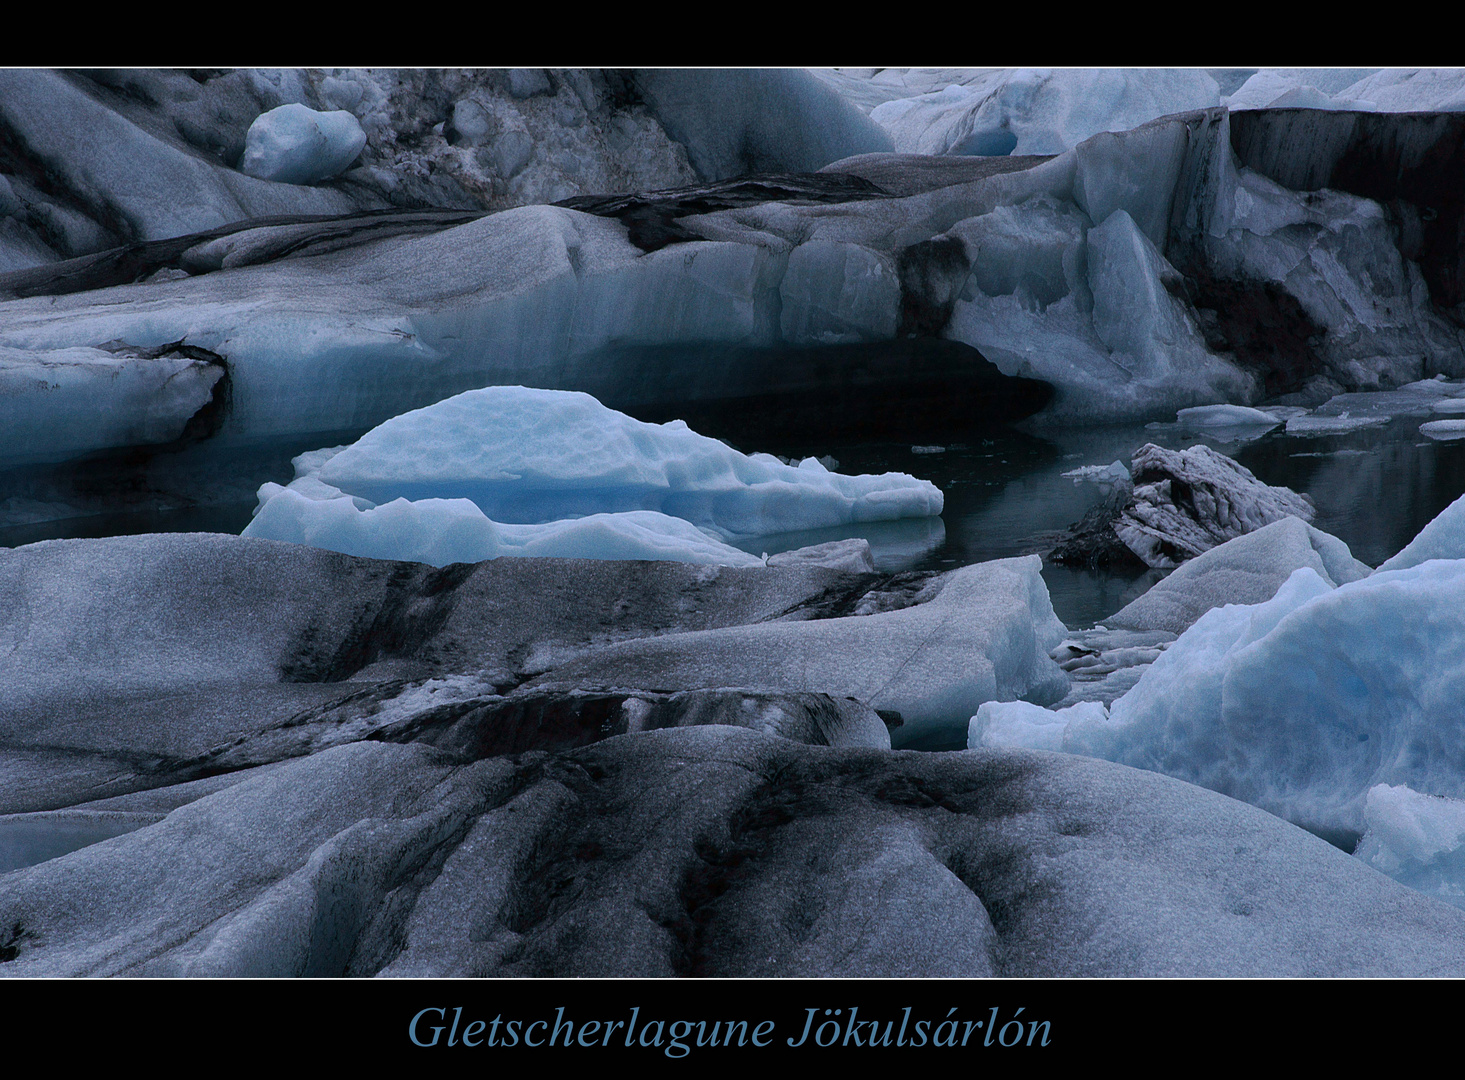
[245,387,942,566]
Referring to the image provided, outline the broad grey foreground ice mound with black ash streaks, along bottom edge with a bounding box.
[0,727,1465,977]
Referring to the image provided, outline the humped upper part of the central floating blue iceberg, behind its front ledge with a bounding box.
[268,387,942,538]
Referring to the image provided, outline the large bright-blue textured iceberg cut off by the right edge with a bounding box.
[1064,560,1465,838]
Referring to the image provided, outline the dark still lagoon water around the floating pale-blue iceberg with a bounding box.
[0,416,1465,629]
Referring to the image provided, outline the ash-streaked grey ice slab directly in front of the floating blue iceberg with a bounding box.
[0,533,966,813]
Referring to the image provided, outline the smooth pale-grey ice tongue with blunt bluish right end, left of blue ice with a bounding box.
[532,555,1068,747]
